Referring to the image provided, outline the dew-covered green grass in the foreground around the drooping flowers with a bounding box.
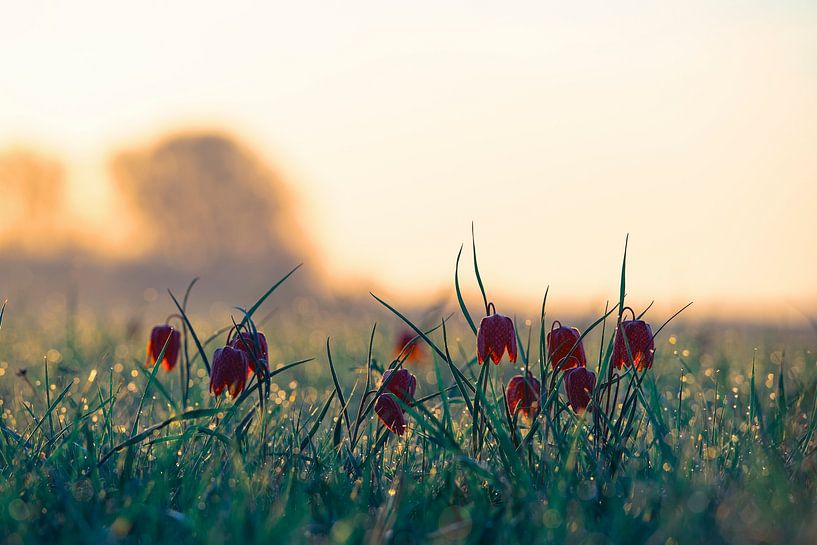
[0,242,817,544]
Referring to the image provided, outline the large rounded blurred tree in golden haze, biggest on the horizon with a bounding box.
[112,133,303,271]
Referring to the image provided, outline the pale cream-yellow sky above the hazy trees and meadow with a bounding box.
[0,0,817,312]
